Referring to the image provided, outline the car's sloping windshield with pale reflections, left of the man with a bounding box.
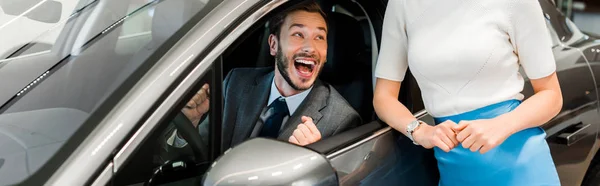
[0,0,217,185]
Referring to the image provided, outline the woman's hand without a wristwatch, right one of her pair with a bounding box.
[452,119,513,154]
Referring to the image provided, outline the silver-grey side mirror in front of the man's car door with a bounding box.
[203,138,338,186]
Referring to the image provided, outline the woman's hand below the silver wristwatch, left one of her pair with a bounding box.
[413,120,458,152]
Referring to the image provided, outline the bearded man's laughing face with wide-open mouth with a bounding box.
[270,10,327,91]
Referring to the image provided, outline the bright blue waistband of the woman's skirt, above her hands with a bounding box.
[433,99,521,124]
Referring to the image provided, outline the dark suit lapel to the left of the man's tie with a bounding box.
[232,72,274,144]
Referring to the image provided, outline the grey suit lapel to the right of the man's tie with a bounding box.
[278,80,329,141]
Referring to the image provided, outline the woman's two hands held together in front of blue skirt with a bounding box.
[413,119,513,154]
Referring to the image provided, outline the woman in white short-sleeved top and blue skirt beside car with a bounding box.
[373,0,562,185]
